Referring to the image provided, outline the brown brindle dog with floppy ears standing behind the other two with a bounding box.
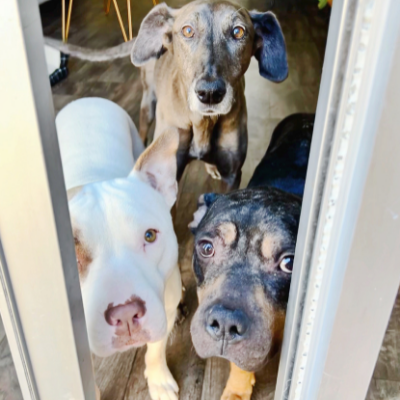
[131,0,288,189]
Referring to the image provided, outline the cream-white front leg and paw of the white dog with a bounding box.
[144,266,182,400]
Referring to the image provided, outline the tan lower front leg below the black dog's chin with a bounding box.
[221,363,256,400]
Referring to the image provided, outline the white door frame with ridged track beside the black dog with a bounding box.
[275,0,400,400]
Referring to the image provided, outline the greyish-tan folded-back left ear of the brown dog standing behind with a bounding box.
[131,3,177,67]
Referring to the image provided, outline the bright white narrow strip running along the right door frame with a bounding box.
[292,0,376,400]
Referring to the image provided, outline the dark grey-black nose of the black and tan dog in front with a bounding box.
[206,305,249,341]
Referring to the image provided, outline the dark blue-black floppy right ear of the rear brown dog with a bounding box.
[249,11,289,82]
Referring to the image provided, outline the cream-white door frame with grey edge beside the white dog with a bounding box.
[0,0,95,400]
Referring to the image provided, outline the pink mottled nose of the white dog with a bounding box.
[104,298,146,326]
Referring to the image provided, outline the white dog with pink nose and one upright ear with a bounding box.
[56,98,182,400]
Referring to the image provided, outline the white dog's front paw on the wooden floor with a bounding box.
[144,366,179,400]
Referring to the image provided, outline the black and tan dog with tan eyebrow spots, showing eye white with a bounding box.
[189,114,314,400]
